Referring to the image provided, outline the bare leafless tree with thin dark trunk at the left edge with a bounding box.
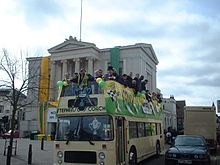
[0,49,39,165]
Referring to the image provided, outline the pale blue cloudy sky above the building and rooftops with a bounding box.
[0,0,220,105]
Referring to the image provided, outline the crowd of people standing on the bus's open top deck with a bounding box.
[63,66,161,101]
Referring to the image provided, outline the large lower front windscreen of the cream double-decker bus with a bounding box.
[56,115,113,141]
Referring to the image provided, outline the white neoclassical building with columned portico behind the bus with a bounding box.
[19,36,158,137]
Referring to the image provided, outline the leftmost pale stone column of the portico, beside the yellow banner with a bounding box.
[49,61,56,99]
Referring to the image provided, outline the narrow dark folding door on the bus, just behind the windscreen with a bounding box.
[115,117,126,165]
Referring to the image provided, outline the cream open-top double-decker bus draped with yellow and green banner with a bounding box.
[54,80,164,165]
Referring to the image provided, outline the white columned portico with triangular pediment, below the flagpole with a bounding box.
[48,36,100,99]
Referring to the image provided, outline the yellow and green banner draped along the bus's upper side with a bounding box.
[104,81,162,119]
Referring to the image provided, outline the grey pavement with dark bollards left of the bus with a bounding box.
[0,139,53,165]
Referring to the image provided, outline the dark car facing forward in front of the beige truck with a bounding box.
[165,135,210,165]
